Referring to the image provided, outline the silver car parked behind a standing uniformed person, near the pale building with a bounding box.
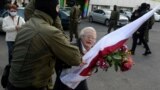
[89,9,129,26]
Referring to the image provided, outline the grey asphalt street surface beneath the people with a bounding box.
[0,19,160,90]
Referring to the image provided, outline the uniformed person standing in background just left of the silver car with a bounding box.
[69,0,80,42]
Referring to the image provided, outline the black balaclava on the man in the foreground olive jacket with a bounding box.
[35,0,58,20]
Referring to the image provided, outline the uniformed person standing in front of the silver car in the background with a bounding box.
[108,5,120,33]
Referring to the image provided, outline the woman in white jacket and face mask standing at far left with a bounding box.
[2,4,25,64]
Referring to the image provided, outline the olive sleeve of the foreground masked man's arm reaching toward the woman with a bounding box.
[45,29,82,66]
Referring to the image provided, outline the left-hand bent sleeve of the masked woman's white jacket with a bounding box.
[2,19,16,32]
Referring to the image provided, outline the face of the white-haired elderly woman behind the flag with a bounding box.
[81,30,97,49]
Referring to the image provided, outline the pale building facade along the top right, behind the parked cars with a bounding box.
[88,0,160,11]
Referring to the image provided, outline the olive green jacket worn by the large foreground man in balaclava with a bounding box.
[9,10,81,88]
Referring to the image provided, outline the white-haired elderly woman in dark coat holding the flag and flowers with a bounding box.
[54,27,97,90]
